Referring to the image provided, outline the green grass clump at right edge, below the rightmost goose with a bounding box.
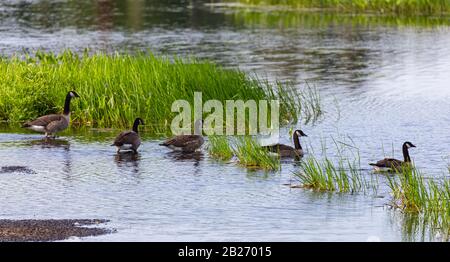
[389,168,450,234]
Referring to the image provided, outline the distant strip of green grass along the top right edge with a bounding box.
[232,0,450,15]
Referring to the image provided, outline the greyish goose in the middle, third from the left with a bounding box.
[159,119,205,153]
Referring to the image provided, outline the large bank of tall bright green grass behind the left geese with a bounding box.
[0,51,307,133]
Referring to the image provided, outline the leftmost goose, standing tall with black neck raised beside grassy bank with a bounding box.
[22,91,80,137]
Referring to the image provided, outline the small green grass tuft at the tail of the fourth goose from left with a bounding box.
[234,136,281,171]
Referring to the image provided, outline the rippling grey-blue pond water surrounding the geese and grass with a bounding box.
[0,0,450,241]
